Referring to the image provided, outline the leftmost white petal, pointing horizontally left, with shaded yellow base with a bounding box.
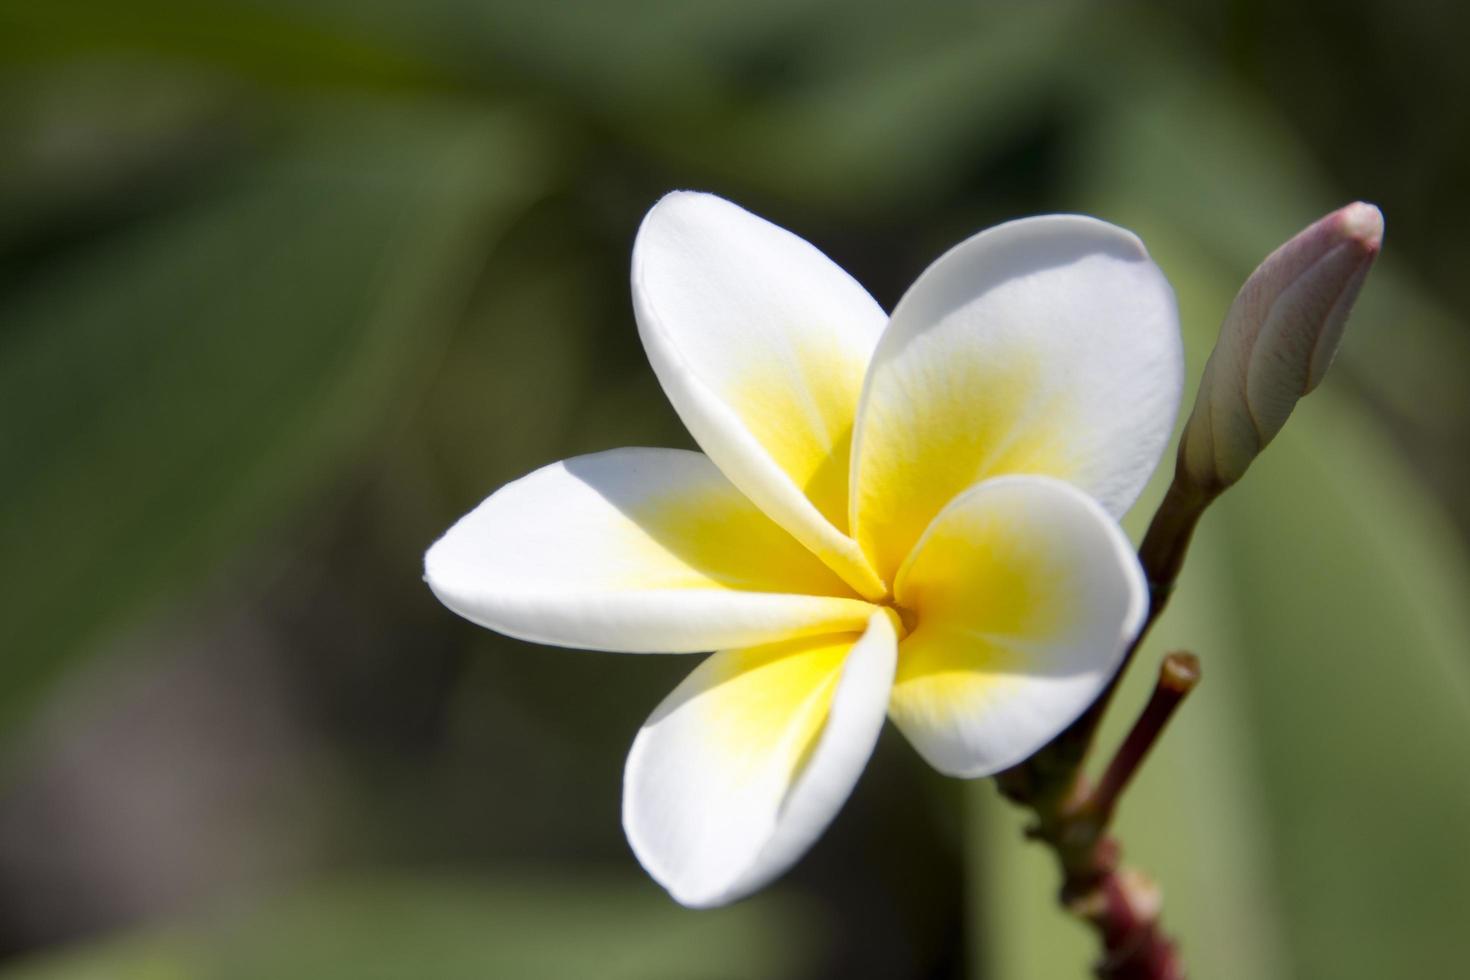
[423,450,873,652]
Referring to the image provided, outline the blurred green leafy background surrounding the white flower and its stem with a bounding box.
[0,0,1470,980]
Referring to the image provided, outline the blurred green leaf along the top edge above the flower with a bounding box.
[316,0,1086,217]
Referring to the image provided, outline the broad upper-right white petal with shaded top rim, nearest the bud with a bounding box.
[851,215,1183,580]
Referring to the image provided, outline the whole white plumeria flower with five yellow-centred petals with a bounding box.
[425,192,1182,907]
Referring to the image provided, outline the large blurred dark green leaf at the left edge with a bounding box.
[0,104,538,740]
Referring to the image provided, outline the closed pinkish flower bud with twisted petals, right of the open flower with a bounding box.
[1179,201,1383,495]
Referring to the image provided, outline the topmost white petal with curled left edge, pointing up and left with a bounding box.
[632,192,888,598]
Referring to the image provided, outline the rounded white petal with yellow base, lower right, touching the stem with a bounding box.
[889,476,1148,776]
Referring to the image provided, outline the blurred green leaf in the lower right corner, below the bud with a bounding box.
[1205,406,1470,979]
